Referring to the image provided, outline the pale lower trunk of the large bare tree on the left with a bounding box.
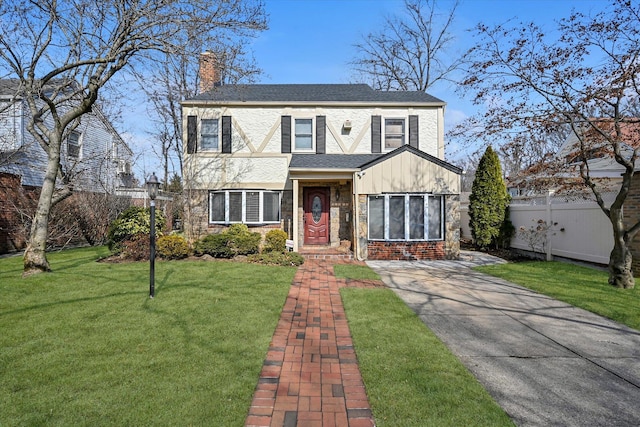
[22,145,60,276]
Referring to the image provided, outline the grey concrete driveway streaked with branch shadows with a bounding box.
[367,252,640,426]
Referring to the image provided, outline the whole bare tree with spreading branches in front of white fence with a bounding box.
[456,0,640,288]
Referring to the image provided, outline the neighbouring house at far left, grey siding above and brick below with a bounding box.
[0,79,133,253]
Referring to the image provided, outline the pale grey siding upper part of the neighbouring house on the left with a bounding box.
[0,80,133,193]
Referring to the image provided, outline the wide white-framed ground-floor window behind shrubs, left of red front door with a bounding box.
[209,190,280,224]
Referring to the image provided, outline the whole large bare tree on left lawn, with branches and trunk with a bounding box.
[0,0,265,274]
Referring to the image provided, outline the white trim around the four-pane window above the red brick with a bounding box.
[367,193,445,242]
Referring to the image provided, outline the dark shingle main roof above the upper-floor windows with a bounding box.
[187,84,444,104]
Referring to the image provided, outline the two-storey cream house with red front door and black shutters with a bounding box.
[182,80,461,260]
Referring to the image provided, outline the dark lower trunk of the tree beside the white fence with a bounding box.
[609,209,635,289]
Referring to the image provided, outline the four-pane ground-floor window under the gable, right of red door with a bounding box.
[368,194,444,241]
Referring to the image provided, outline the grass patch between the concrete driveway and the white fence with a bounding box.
[475,261,640,329]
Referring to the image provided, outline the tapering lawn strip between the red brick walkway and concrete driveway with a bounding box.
[341,288,513,427]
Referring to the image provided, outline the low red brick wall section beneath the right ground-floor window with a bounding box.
[367,241,446,261]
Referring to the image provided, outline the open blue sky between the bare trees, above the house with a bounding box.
[130,0,608,177]
